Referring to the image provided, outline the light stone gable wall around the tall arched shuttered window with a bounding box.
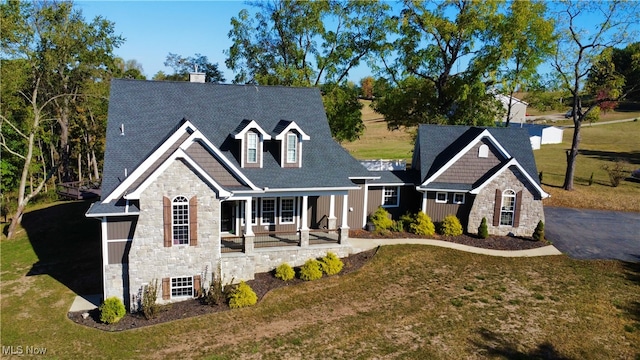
[129,160,220,310]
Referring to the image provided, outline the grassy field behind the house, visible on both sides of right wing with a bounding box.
[342,102,640,211]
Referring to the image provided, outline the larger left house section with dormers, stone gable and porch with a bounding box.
[87,79,372,310]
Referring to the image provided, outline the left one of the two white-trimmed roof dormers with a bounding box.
[231,120,271,168]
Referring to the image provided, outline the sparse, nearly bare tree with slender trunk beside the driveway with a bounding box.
[552,1,638,190]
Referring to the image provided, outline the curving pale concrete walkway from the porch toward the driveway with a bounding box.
[349,238,562,257]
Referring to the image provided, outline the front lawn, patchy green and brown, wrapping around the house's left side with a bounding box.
[0,203,640,359]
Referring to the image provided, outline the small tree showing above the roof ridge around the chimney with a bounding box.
[162,53,225,83]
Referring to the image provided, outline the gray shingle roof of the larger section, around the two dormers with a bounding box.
[91,79,368,214]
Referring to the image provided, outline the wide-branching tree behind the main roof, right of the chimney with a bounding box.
[225,0,391,139]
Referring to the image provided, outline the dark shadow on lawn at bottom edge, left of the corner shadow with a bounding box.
[472,328,571,360]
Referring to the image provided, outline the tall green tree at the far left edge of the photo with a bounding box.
[0,1,122,238]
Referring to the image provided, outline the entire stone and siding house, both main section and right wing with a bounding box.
[86,77,548,310]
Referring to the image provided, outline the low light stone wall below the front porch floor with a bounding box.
[221,245,352,284]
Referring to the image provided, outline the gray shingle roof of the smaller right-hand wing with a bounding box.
[416,124,539,186]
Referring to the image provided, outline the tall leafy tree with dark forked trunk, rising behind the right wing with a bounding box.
[374,0,508,128]
